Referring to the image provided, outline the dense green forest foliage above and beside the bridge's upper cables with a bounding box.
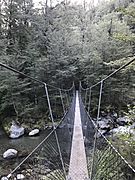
[0,0,135,124]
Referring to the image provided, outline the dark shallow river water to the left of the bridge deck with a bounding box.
[0,126,71,177]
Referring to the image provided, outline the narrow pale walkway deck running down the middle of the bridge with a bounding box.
[68,92,88,180]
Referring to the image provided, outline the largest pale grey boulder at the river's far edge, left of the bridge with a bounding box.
[10,122,24,139]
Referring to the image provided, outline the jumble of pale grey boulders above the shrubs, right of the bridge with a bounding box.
[93,112,135,140]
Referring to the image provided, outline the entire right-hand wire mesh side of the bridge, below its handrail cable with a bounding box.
[80,90,135,180]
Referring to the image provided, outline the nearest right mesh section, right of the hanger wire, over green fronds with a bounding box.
[91,137,135,180]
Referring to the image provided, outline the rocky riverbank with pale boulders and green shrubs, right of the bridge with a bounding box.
[93,113,135,168]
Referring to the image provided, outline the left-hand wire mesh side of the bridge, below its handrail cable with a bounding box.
[4,112,72,180]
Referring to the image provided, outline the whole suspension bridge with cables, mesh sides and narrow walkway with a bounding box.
[0,59,135,180]
